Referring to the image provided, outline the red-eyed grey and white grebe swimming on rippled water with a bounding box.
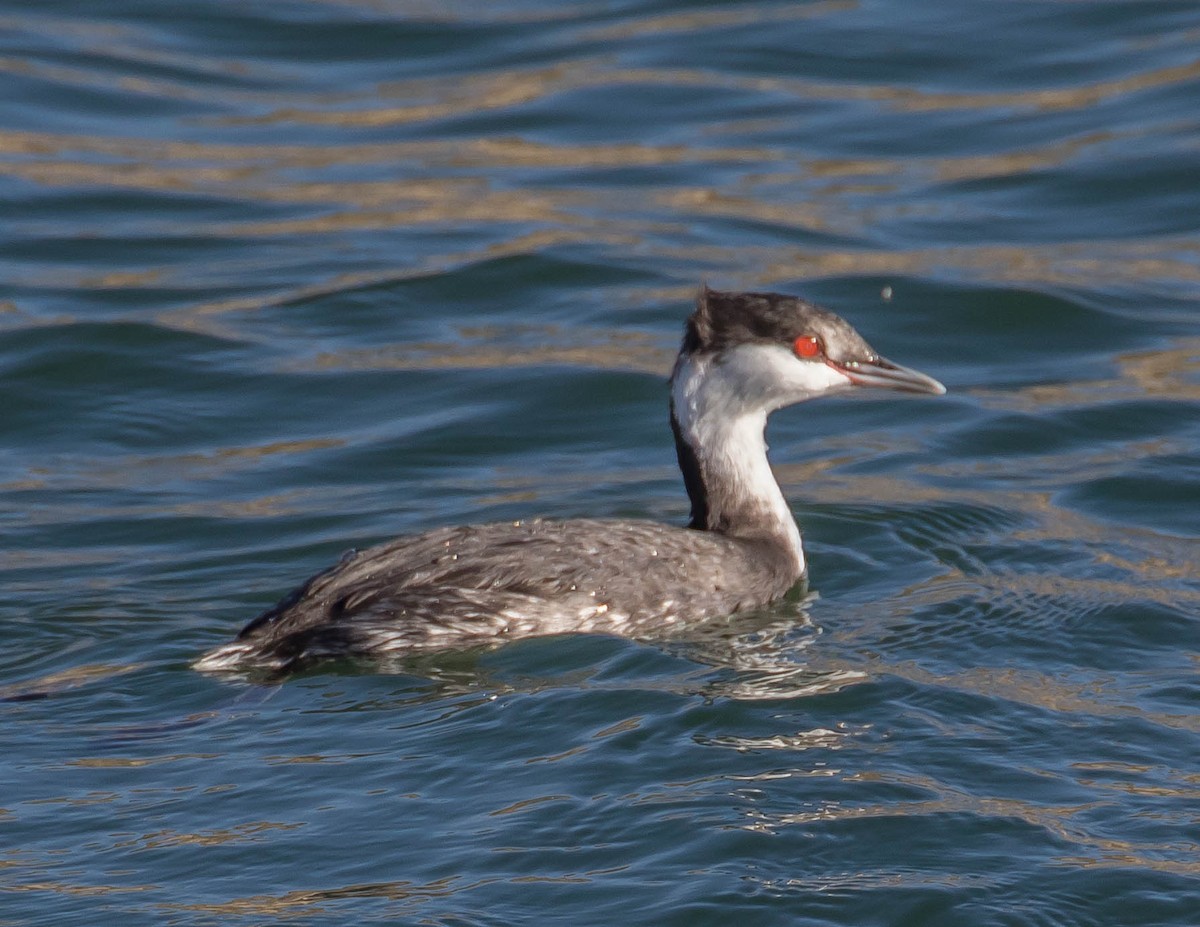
[196,287,946,671]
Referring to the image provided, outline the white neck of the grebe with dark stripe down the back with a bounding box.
[671,357,804,579]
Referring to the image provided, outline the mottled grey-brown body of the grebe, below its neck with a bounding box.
[199,519,796,666]
